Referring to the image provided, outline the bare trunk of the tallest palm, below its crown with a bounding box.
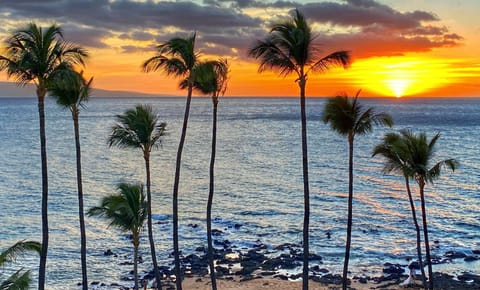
[299,75,310,290]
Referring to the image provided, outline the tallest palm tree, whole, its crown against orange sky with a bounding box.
[249,10,350,290]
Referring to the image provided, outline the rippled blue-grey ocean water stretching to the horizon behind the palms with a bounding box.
[0,97,480,289]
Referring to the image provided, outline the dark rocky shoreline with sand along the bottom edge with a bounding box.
[91,243,480,290]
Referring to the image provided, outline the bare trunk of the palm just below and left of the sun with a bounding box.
[342,137,354,290]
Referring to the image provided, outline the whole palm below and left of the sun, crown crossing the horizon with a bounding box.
[322,91,393,289]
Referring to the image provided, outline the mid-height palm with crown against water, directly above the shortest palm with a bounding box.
[108,105,167,289]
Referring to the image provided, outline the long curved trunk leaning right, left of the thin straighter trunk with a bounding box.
[173,85,192,290]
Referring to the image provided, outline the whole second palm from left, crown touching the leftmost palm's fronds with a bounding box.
[48,71,93,290]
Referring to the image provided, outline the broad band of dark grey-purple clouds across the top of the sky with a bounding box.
[0,0,463,57]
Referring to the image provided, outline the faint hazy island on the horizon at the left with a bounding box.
[0,82,171,98]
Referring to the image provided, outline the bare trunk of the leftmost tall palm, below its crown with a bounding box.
[37,87,48,290]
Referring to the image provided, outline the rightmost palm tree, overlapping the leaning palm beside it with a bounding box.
[400,130,458,290]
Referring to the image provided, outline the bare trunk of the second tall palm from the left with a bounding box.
[72,108,88,290]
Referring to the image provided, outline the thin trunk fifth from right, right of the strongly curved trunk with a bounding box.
[207,100,218,290]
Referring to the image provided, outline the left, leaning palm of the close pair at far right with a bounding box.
[372,133,427,290]
